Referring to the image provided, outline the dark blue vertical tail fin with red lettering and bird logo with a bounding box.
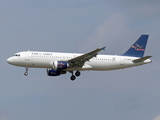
[122,35,149,57]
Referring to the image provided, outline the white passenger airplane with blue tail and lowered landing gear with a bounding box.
[7,35,152,81]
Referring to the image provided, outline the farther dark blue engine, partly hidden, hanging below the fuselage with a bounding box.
[47,69,66,76]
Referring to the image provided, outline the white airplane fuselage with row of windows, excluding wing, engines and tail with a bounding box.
[7,51,151,71]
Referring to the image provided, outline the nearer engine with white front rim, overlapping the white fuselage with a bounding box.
[53,61,69,70]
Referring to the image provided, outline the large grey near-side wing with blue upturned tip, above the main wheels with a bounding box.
[68,47,106,67]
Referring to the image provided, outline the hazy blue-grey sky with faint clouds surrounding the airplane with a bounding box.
[0,0,160,120]
